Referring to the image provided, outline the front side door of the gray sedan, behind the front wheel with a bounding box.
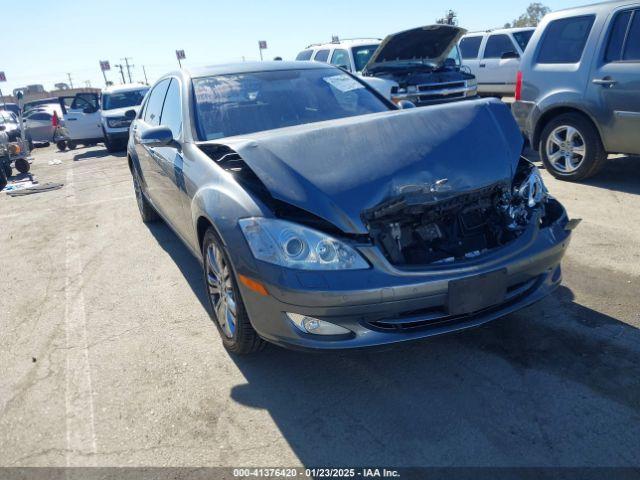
[155,78,193,238]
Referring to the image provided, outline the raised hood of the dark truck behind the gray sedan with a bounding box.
[364,24,467,71]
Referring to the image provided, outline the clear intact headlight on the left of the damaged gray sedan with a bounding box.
[239,217,369,270]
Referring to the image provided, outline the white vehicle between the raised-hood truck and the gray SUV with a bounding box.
[459,27,535,97]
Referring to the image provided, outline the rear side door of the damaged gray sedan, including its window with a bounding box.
[132,78,170,216]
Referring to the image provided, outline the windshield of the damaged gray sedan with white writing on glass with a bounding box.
[193,68,390,140]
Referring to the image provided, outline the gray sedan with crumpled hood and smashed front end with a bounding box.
[128,62,574,353]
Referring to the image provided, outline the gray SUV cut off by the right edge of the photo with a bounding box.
[513,0,640,180]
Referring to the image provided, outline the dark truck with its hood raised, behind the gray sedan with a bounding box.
[362,24,477,106]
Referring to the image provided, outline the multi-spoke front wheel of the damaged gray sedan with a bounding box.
[202,227,264,355]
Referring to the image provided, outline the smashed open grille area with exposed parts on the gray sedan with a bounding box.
[363,159,549,266]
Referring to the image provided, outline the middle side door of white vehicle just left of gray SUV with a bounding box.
[478,33,520,94]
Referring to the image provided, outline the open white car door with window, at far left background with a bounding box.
[59,93,102,141]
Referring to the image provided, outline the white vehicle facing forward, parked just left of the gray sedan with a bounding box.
[101,84,149,152]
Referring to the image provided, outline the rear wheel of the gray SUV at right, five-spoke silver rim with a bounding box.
[540,113,607,181]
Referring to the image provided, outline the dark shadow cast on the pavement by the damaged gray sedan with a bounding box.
[150,220,640,466]
